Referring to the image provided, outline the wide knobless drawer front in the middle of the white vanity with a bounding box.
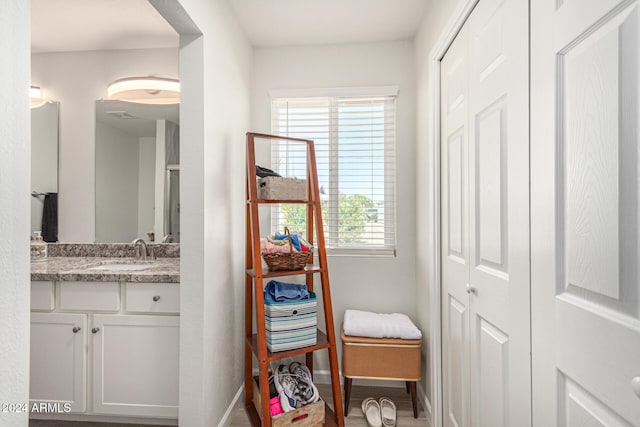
[59,282,120,311]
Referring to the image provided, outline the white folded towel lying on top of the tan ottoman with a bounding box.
[343,310,422,340]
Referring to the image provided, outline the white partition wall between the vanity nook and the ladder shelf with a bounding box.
[151,0,252,427]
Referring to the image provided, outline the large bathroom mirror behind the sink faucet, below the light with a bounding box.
[95,100,180,243]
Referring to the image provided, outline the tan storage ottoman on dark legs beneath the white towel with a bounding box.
[340,330,422,418]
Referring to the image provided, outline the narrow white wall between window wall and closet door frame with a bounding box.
[414,0,466,425]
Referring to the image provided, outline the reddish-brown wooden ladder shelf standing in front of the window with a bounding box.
[244,132,344,427]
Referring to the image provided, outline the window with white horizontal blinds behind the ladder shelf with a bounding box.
[271,96,395,255]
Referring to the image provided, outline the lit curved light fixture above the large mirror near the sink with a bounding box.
[107,77,180,104]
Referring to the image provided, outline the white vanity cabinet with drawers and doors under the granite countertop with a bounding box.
[30,281,180,420]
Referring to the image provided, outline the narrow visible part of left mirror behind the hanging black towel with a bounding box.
[31,101,60,241]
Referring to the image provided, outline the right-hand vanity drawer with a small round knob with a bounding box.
[125,283,180,314]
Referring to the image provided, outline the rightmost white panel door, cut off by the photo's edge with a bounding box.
[531,0,640,427]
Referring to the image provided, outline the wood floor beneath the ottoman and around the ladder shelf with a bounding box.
[231,384,429,427]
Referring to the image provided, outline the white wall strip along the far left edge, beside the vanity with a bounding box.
[0,0,31,427]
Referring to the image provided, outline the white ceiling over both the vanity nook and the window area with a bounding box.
[31,0,429,53]
